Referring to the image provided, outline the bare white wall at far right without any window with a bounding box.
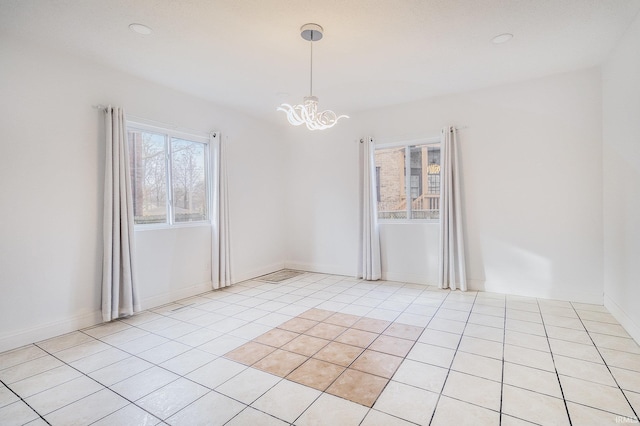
[603,12,640,342]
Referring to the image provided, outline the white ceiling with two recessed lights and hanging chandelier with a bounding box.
[0,0,640,122]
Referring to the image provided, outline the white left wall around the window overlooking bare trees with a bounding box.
[0,37,285,351]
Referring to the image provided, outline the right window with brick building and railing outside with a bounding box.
[375,141,440,220]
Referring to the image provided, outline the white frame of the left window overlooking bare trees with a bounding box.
[126,120,213,231]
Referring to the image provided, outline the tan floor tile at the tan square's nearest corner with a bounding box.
[326,368,388,407]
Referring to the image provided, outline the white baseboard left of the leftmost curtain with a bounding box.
[0,311,102,352]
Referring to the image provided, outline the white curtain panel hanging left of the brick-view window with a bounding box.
[358,137,382,281]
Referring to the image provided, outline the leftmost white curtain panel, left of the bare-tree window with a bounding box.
[102,106,141,321]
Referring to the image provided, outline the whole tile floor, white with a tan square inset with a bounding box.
[0,273,640,426]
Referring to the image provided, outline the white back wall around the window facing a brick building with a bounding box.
[287,69,603,303]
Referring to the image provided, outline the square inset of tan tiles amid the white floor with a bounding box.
[224,308,424,407]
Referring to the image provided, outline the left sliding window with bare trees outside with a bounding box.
[127,123,209,225]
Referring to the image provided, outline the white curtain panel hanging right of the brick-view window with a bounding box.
[438,127,467,291]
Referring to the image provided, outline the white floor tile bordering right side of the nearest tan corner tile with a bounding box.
[374,381,438,424]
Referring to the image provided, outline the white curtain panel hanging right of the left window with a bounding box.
[209,132,232,289]
